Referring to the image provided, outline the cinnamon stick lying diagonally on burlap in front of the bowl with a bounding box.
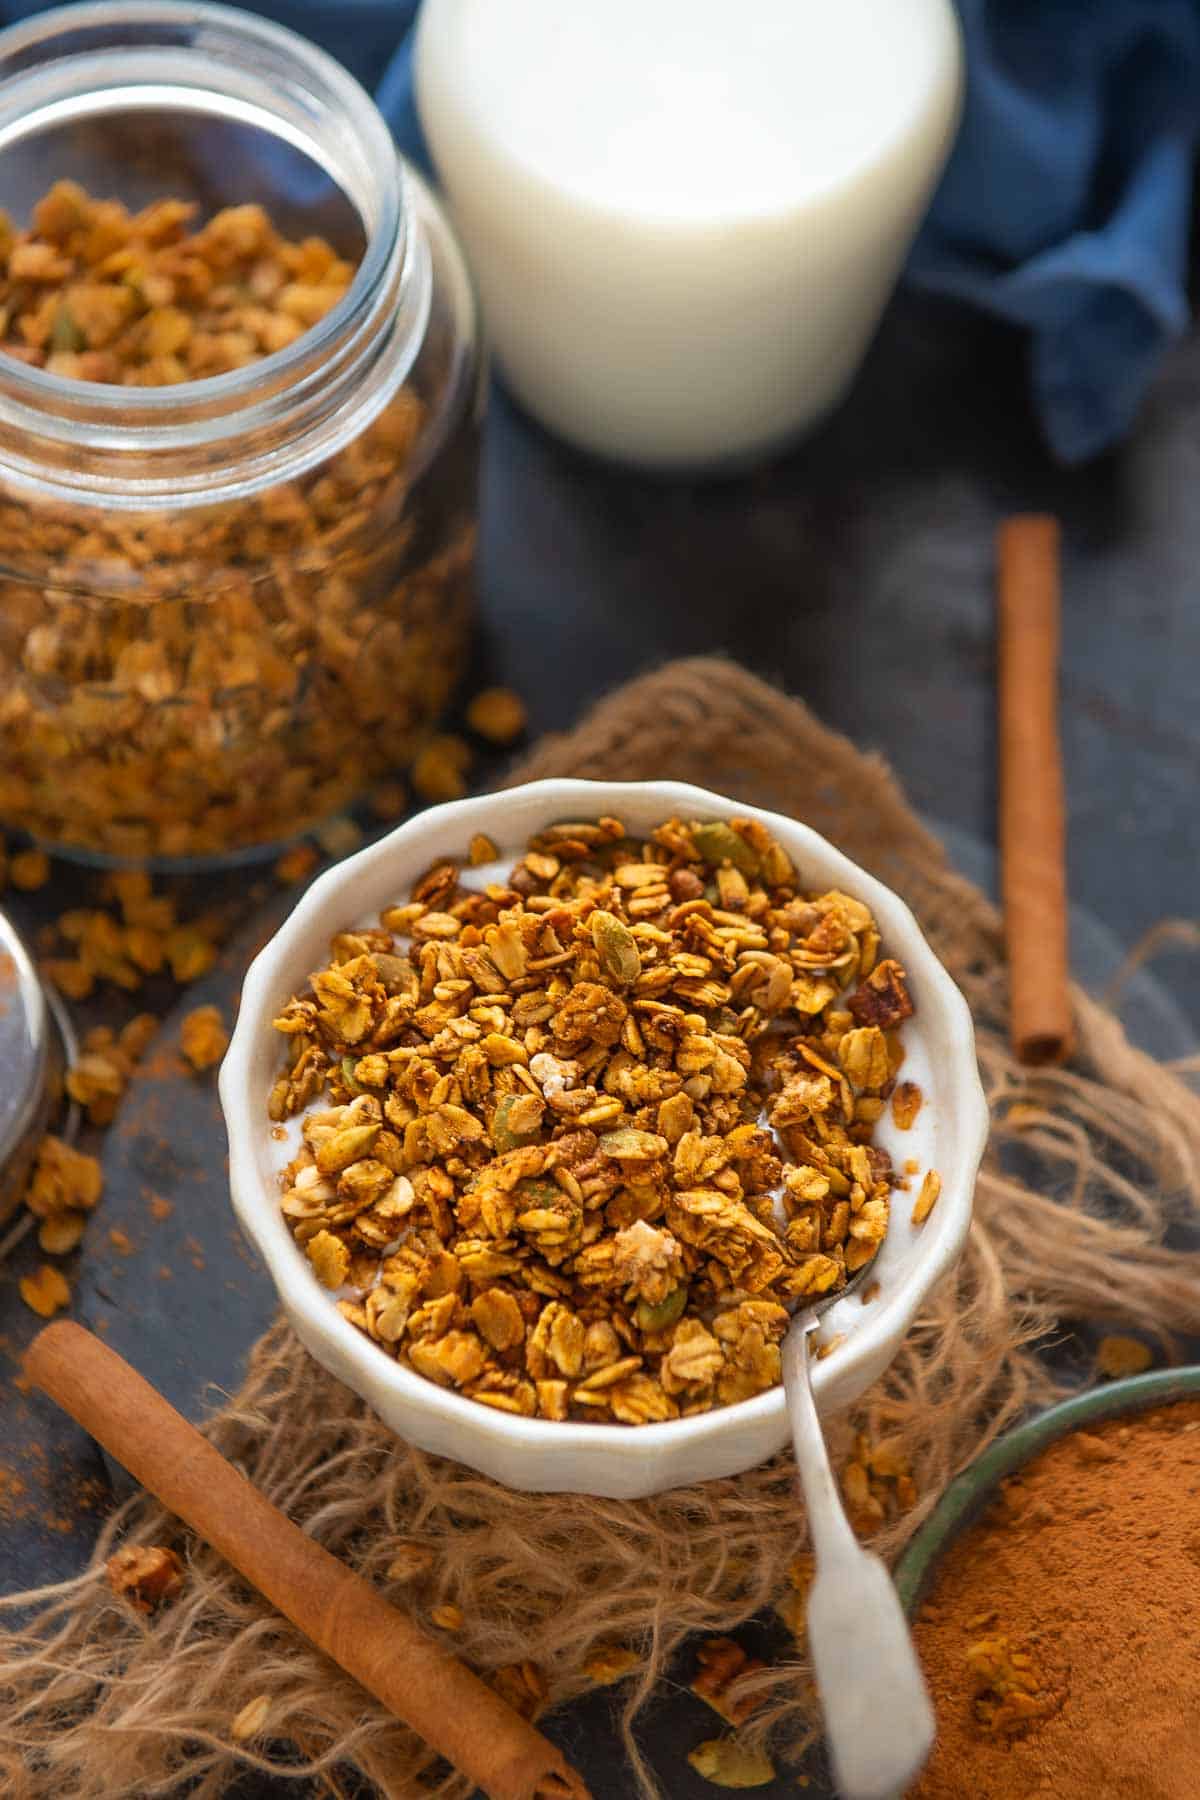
[25,1321,588,1800]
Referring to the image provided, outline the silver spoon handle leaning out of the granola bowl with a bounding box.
[783,1319,934,1800]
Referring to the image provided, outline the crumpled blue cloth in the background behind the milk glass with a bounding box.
[0,0,1200,463]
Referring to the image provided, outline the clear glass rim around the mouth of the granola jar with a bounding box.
[0,0,410,448]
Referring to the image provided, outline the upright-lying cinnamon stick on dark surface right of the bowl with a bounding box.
[997,513,1074,1064]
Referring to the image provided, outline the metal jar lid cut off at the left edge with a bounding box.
[0,913,68,1226]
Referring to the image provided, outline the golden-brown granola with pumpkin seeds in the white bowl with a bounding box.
[270,819,912,1424]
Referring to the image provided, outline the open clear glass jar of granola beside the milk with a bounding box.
[0,0,482,864]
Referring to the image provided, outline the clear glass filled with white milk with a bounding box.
[416,0,963,470]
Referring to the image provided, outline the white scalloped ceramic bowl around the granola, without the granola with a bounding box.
[221,781,988,1499]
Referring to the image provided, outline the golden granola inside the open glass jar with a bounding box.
[0,182,475,860]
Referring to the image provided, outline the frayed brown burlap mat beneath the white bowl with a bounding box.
[0,659,1200,1800]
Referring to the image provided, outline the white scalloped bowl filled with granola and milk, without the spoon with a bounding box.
[221,781,988,1498]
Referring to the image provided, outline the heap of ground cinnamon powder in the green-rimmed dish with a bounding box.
[910,1400,1200,1800]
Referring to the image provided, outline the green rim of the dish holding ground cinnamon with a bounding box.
[896,1366,1200,1616]
